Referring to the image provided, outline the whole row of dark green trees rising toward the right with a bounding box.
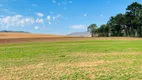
[87,2,142,37]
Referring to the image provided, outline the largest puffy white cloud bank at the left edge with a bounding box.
[0,15,35,28]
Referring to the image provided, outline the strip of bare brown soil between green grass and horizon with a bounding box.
[0,33,142,44]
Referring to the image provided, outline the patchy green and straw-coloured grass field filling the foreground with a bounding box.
[0,40,142,80]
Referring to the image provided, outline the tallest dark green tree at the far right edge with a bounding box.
[126,2,142,36]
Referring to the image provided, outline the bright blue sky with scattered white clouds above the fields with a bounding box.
[0,0,142,35]
